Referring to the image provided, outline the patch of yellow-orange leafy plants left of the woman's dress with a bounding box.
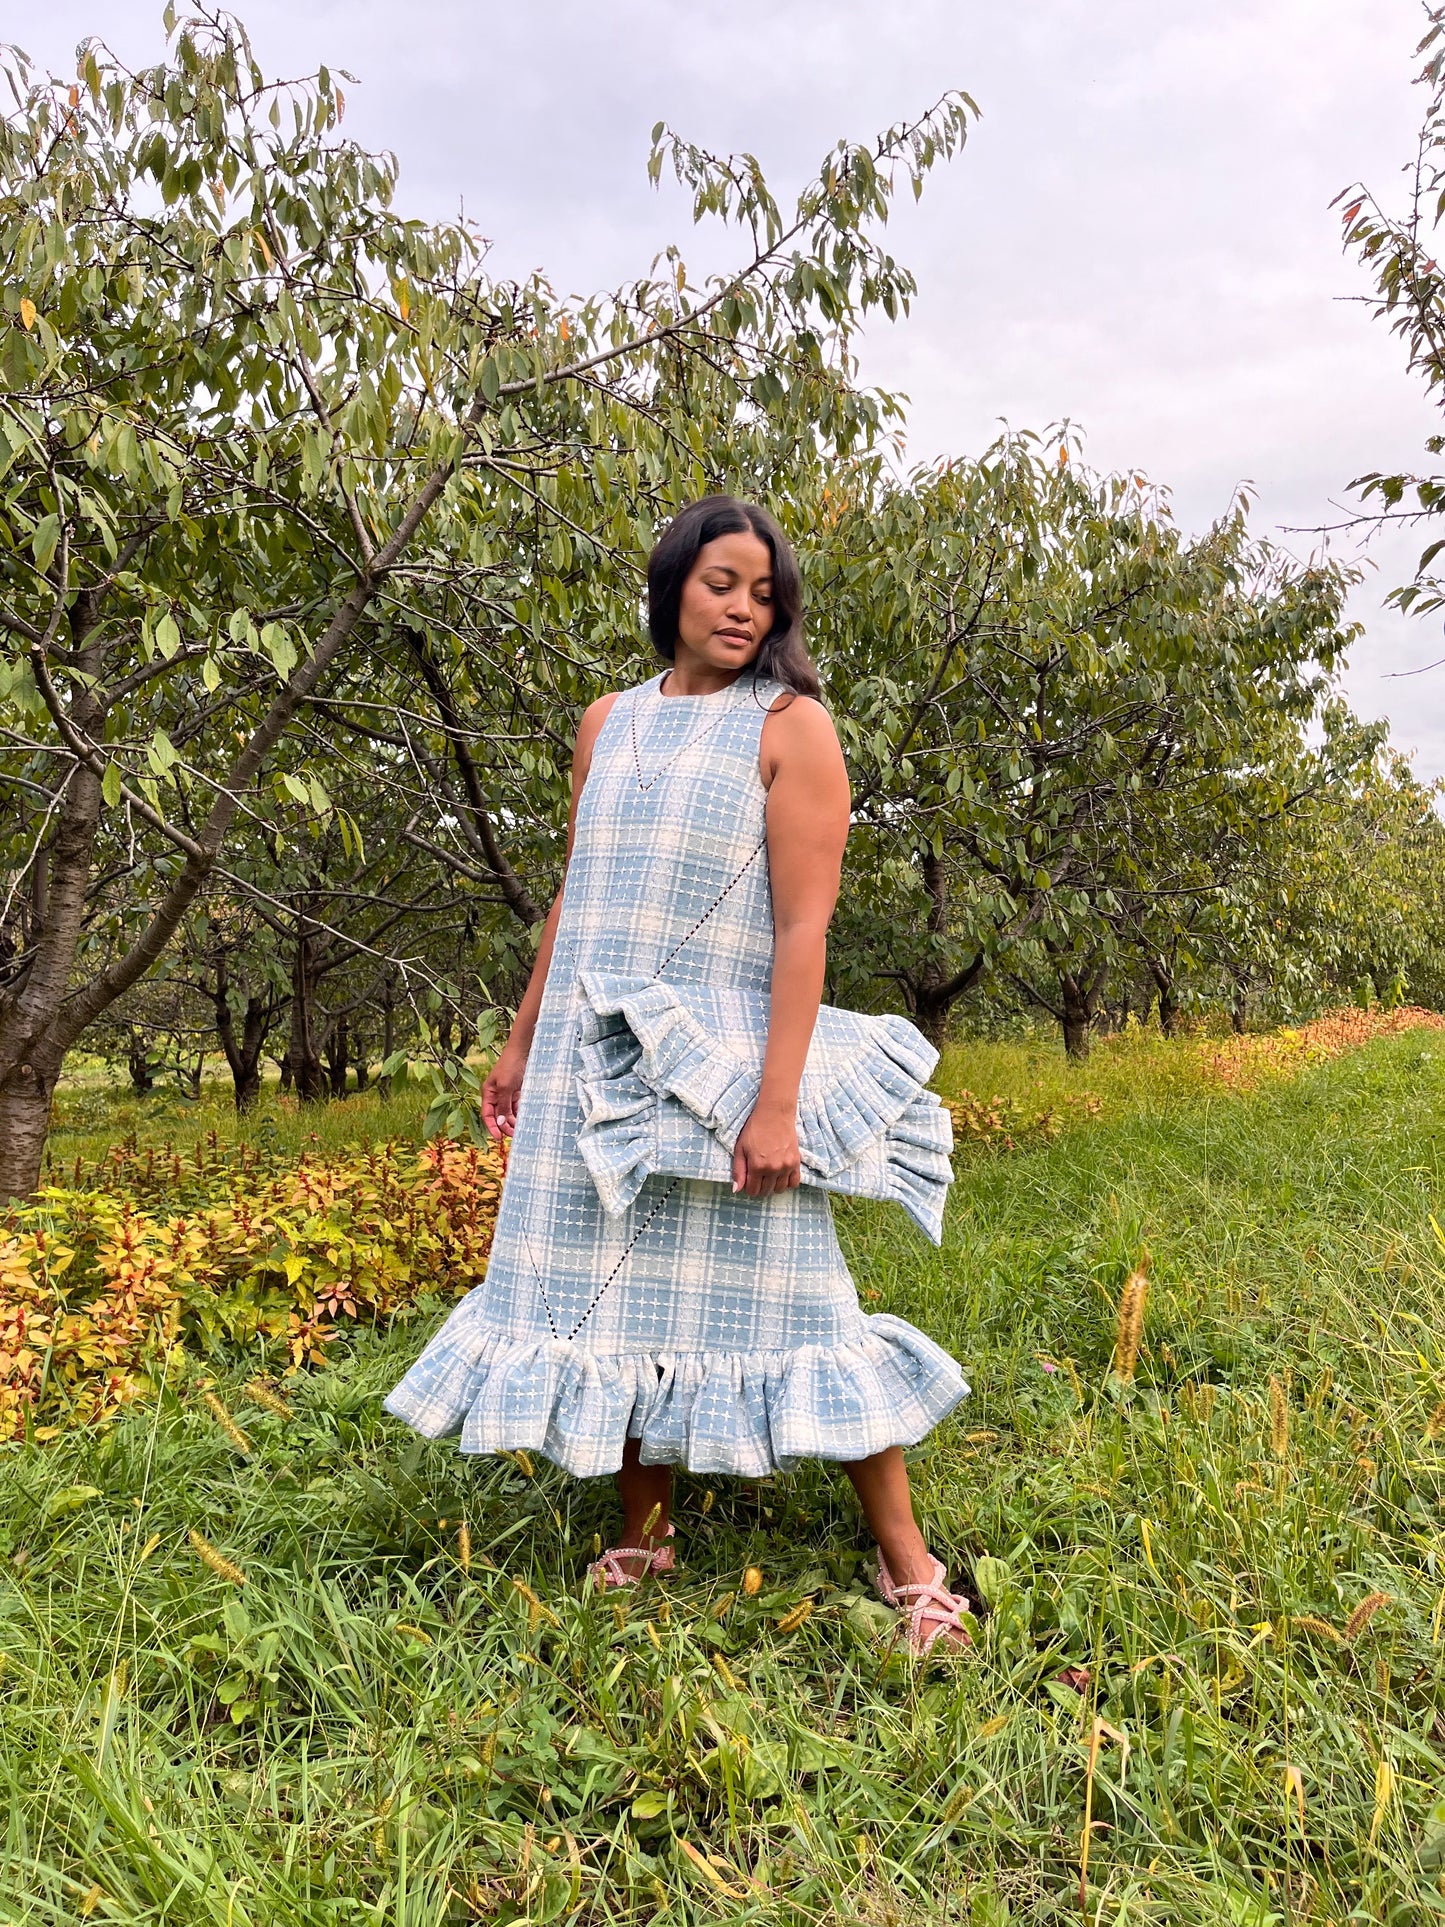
[0,1141,501,1438]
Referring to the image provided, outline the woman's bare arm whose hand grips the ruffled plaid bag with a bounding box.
[732,696,850,1199]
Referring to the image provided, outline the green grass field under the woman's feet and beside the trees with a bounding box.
[0,1031,1445,1927]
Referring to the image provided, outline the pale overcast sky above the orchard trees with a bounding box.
[19,0,1445,777]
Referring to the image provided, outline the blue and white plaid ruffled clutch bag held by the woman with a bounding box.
[578,971,954,1245]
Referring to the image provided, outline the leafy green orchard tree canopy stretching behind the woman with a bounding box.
[0,15,1441,1195]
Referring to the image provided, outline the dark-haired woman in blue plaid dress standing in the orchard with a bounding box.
[387,495,967,1651]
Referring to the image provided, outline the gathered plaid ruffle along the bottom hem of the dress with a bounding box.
[385,1305,969,1478]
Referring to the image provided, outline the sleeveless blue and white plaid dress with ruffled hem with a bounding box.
[385,671,969,1478]
